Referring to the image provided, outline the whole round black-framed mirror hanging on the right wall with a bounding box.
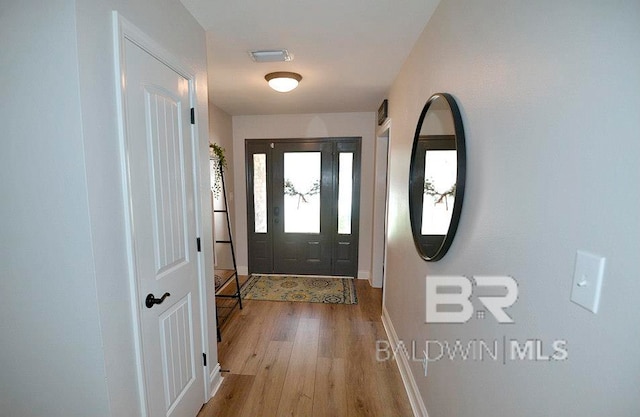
[409,93,466,261]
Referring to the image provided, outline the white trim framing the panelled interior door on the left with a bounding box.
[112,11,212,416]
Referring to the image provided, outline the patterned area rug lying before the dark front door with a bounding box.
[242,274,358,304]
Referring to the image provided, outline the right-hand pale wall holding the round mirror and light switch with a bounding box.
[385,0,640,417]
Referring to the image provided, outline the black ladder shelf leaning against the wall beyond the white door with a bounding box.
[213,164,242,341]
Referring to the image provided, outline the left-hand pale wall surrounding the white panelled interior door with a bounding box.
[0,0,217,416]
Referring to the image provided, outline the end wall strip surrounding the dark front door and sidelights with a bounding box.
[233,112,376,279]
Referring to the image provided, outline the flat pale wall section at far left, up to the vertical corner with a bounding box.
[0,0,109,417]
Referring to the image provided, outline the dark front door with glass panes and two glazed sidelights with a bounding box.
[245,138,361,277]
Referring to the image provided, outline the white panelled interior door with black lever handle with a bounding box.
[124,40,204,417]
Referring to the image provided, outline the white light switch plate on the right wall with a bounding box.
[571,250,605,313]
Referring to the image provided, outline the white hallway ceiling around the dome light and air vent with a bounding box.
[181,0,439,115]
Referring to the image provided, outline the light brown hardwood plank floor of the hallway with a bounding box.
[198,280,413,417]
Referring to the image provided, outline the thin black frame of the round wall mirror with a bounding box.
[409,93,467,262]
